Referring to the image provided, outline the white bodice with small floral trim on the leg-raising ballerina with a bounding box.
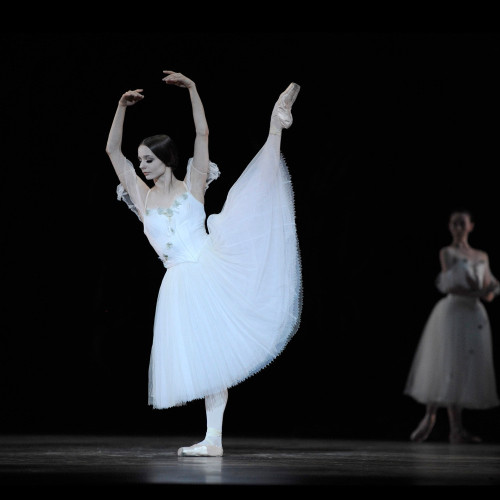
[144,191,208,269]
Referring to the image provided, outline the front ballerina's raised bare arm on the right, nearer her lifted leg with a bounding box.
[163,70,209,203]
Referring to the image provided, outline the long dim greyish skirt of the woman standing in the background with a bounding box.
[404,295,499,409]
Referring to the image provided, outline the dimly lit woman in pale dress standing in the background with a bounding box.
[404,210,500,443]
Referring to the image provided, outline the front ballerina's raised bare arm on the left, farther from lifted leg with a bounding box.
[106,89,149,199]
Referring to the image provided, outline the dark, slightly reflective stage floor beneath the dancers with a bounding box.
[0,435,500,489]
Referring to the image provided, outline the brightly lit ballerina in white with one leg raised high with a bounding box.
[106,70,302,456]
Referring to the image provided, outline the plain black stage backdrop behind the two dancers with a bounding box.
[0,32,500,441]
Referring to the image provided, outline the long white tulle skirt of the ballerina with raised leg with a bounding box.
[149,136,302,408]
